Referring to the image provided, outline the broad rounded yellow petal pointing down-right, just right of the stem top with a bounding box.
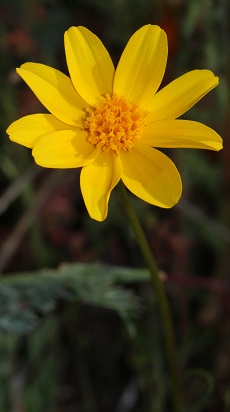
[120,143,182,208]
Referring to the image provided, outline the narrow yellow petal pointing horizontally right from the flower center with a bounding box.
[141,120,223,150]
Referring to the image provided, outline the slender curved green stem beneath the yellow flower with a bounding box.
[118,182,182,412]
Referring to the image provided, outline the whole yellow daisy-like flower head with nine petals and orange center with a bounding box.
[7,25,222,221]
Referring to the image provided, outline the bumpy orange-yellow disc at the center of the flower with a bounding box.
[84,94,147,154]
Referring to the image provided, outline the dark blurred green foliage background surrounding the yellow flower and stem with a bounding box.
[0,0,230,412]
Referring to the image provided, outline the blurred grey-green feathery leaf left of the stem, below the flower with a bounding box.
[0,264,148,334]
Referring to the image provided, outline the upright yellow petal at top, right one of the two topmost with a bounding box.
[114,25,168,110]
